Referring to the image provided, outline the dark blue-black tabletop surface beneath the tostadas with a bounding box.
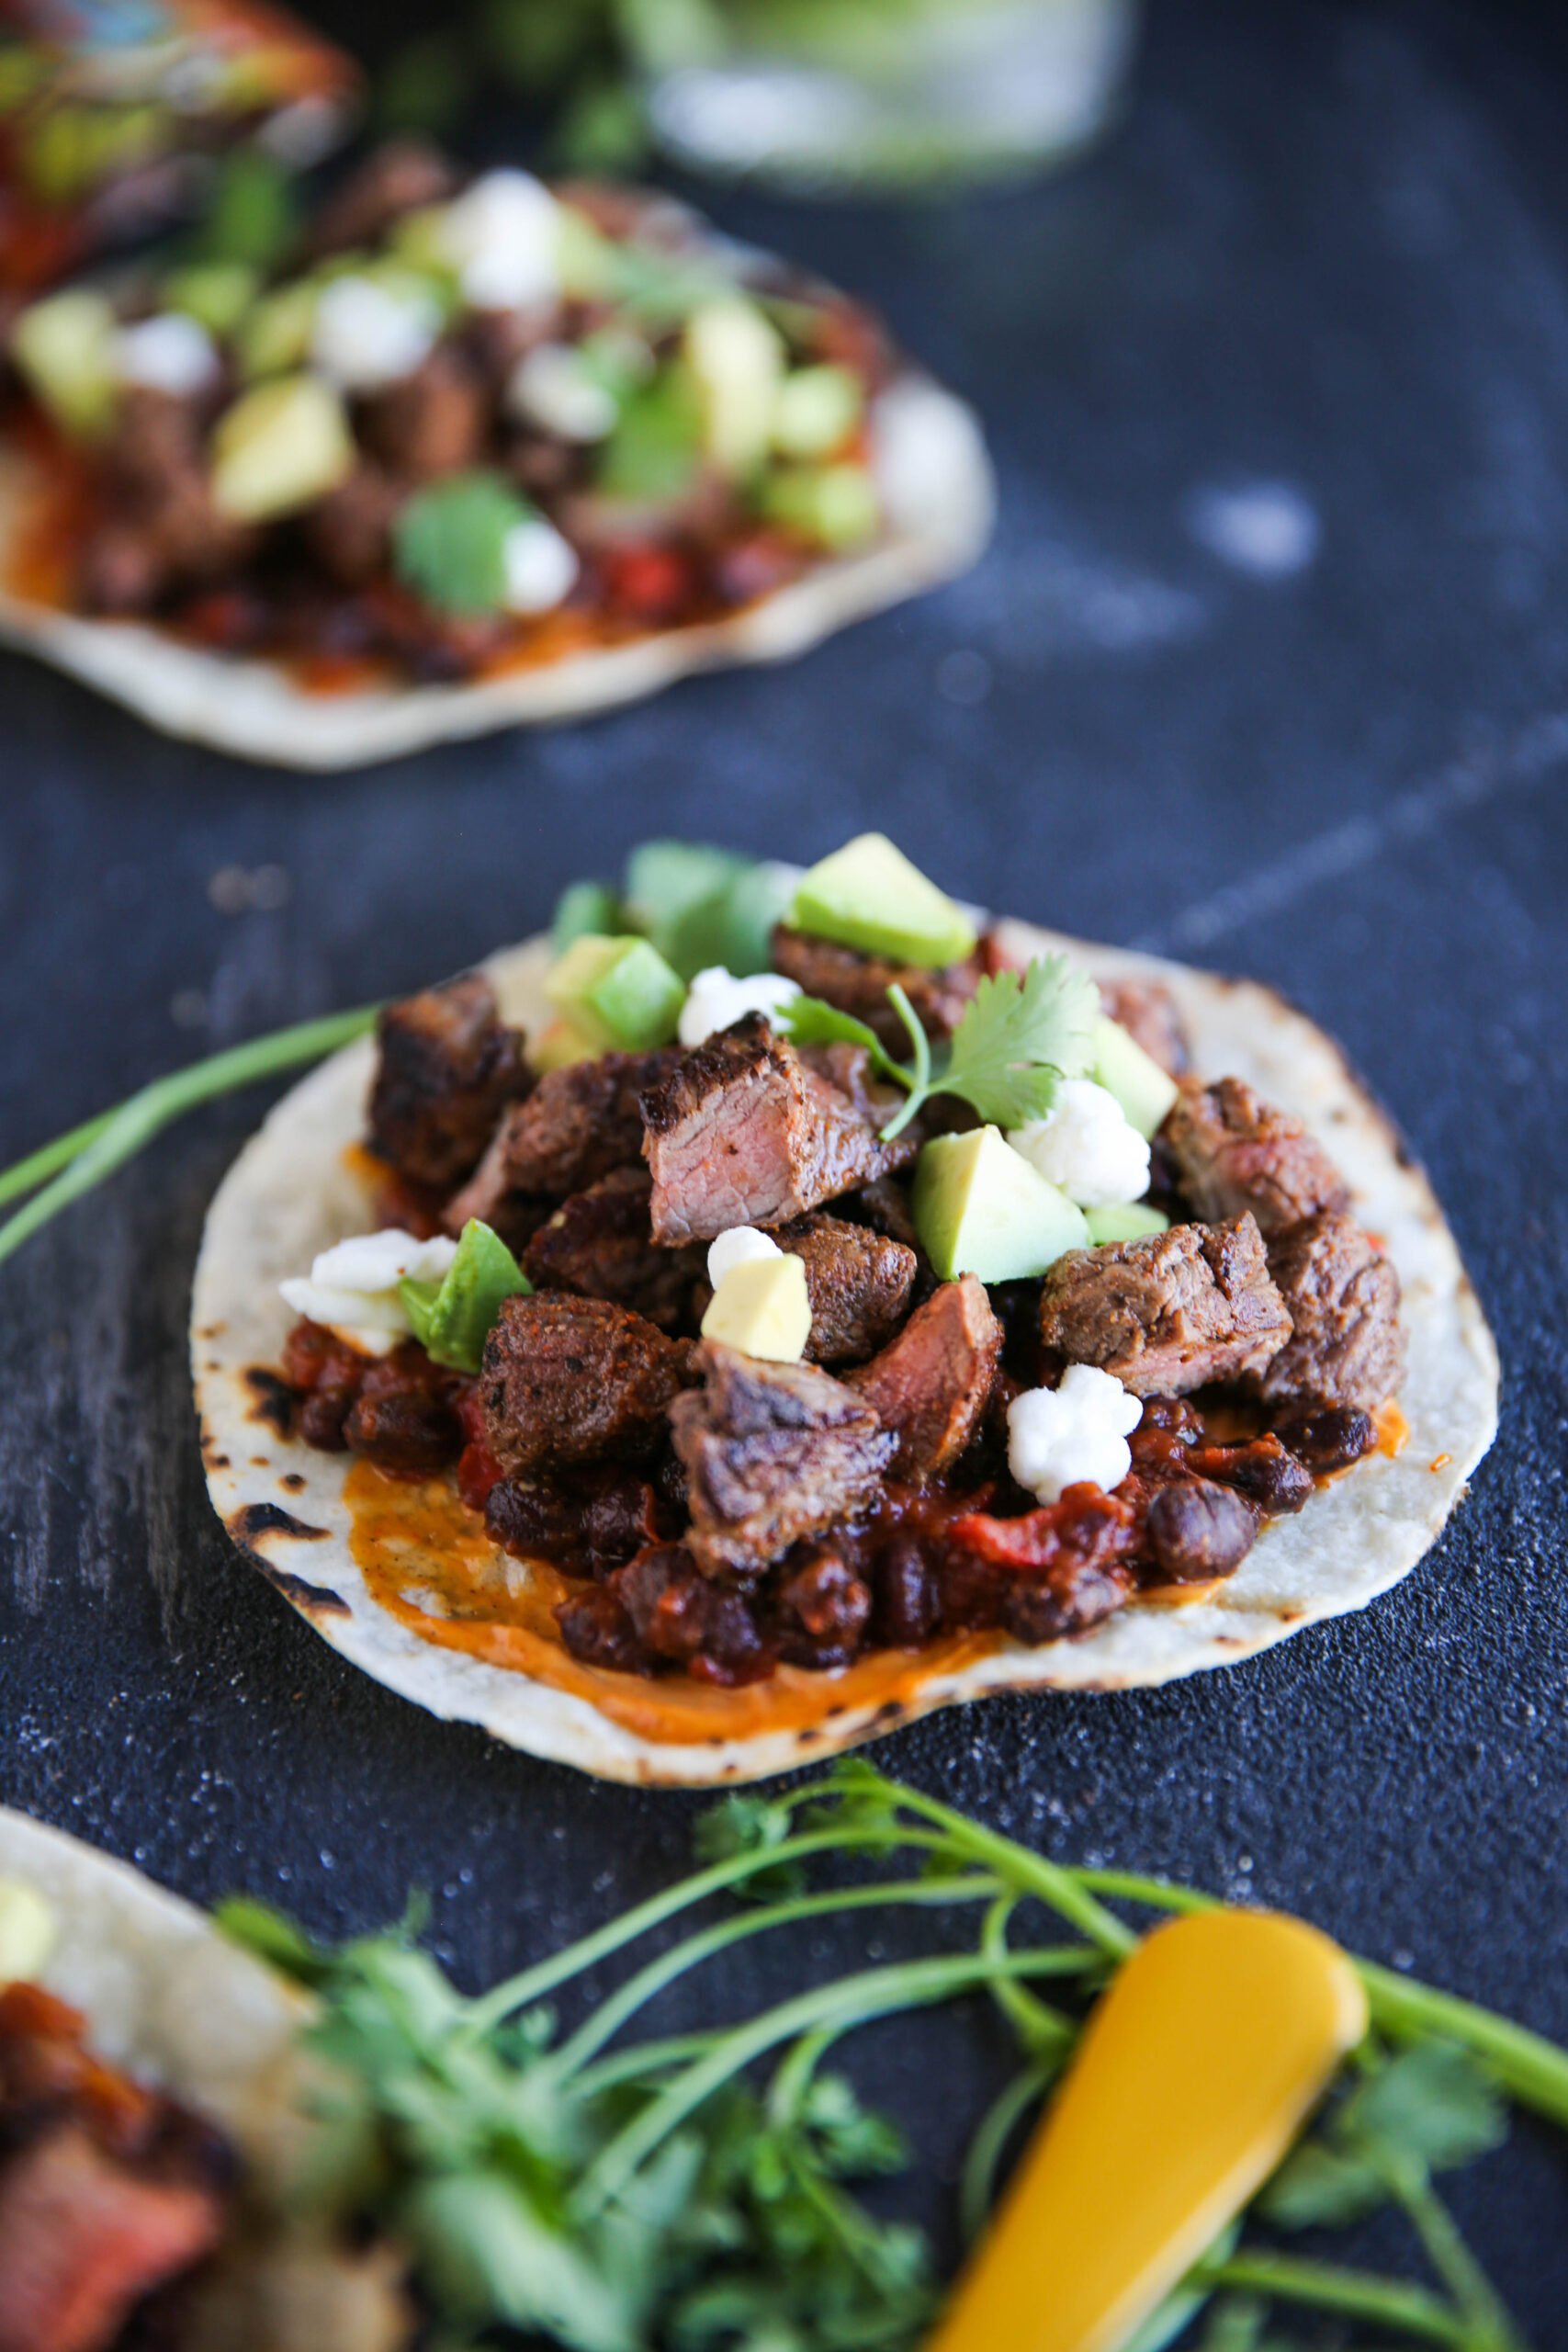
[0,0,1568,2345]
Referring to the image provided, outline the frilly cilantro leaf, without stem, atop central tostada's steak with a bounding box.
[931,955,1100,1126]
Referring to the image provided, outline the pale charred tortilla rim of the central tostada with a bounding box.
[193,922,1500,1785]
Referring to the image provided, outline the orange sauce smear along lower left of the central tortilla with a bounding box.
[344,1461,1001,1743]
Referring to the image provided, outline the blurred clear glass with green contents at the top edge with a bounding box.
[630,0,1138,195]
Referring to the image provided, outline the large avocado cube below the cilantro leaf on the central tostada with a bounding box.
[915,1126,1089,1282]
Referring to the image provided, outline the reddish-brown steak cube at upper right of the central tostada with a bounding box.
[1159,1077,1349,1239]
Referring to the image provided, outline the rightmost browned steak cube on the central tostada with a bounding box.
[1260,1211,1405,1411]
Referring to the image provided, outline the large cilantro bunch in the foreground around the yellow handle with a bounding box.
[221,1761,1568,2352]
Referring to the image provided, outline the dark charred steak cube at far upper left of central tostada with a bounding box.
[369,971,529,1193]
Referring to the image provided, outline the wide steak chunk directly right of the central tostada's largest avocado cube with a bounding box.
[1039,1216,1291,1397]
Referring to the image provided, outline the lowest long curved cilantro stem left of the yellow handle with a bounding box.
[573,1952,1090,2218]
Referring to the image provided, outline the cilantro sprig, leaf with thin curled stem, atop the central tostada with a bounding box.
[778,955,1100,1141]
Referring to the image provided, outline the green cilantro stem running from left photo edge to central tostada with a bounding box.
[0,1004,376,1259]
